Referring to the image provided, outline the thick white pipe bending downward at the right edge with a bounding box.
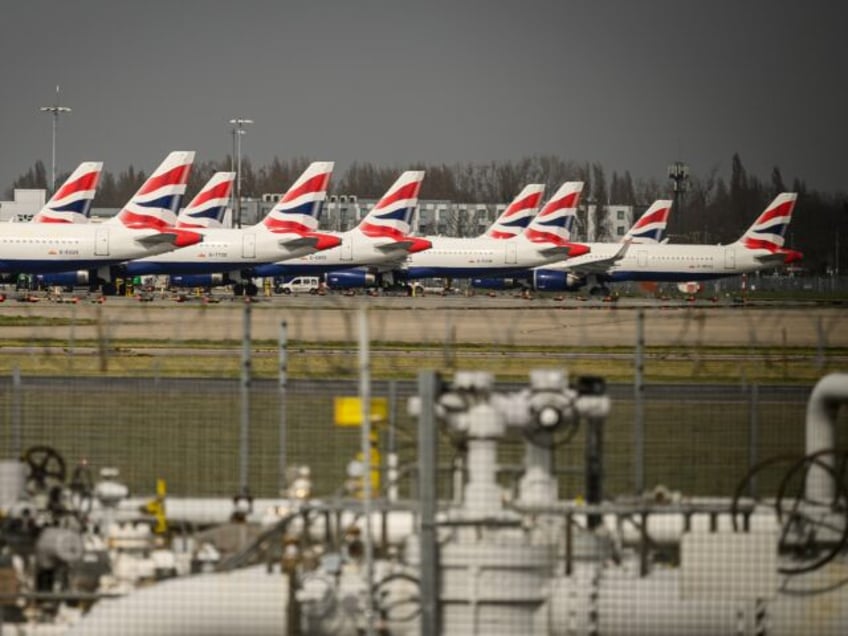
[806,373,848,504]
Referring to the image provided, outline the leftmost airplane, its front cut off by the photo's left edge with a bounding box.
[0,151,203,280]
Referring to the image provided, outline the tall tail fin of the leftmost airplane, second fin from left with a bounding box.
[109,150,194,229]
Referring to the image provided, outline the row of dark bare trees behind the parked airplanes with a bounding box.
[6,153,848,273]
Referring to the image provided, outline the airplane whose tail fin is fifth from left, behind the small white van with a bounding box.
[254,170,431,287]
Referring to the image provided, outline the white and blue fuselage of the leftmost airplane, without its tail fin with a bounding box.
[0,223,184,274]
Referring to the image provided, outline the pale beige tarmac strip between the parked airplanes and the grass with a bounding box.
[0,295,848,348]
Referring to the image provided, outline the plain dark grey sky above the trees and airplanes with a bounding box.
[0,0,848,196]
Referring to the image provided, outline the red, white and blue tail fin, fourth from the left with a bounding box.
[262,161,335,233]
